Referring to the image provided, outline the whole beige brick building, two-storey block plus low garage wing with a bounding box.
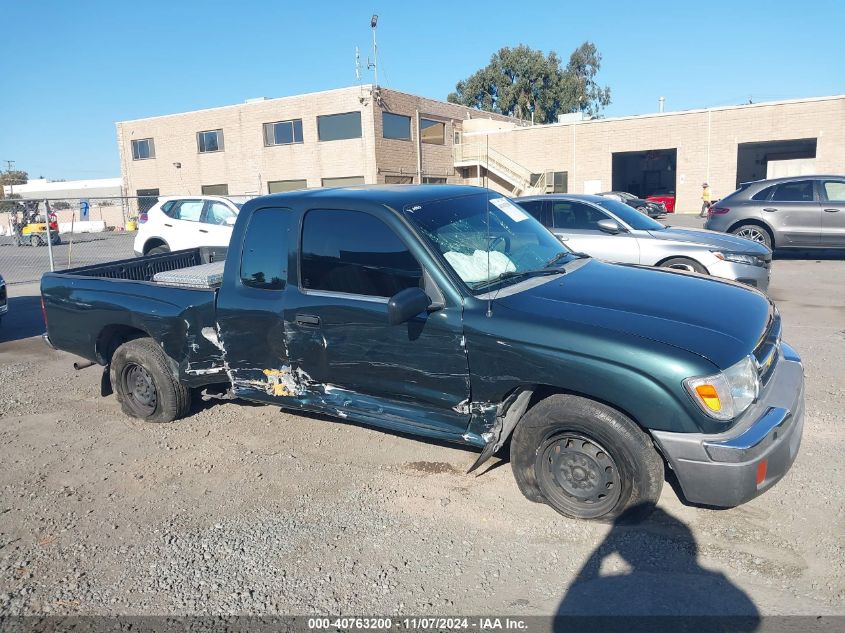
[117,85,845,211]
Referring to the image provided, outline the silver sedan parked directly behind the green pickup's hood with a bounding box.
[515,194,772,292]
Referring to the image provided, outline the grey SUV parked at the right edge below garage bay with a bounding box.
[704,176,845,249]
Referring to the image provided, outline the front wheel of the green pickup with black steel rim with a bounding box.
[511,394,664,521]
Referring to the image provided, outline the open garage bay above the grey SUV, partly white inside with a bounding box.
[736,138,816,187]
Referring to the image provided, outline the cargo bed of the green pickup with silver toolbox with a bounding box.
[41,247,226,386]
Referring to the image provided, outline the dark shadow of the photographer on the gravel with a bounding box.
[555,507,760,632]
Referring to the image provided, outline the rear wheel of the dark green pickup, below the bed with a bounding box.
[109,338,191,422]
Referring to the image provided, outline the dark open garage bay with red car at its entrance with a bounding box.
[613,148,678,198]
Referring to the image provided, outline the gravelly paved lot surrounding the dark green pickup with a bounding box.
[0,218,845,615]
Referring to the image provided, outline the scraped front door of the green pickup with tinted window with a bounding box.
[285,209,470,435]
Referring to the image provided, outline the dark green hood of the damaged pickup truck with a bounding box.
[496,260,774,369]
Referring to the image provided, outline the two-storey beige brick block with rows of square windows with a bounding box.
[117,85,516,200]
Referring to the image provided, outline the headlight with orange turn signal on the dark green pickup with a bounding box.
[684,356,760,420]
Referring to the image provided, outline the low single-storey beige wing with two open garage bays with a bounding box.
[456,95,845,212]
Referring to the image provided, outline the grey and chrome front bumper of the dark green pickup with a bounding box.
[651,343,804,507]
